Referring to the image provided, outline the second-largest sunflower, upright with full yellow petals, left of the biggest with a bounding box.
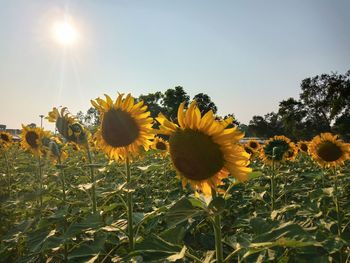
[91,94,154,160]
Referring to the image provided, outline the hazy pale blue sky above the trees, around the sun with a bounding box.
[0,0,350,129]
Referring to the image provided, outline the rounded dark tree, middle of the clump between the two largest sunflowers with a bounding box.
[162,86,190,121]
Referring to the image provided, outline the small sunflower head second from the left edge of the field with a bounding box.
[21,125,50,156]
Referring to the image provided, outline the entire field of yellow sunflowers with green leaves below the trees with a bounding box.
[0,94,350,263]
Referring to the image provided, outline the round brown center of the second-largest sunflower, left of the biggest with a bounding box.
[102,109,140,147]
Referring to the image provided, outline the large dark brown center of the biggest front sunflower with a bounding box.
[169,129,224,181]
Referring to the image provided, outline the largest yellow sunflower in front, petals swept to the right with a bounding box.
[157,101,251,196]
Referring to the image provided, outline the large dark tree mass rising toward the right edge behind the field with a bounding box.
[248,71,350,140]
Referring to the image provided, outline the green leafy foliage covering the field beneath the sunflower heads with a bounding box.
[0,146,350,262]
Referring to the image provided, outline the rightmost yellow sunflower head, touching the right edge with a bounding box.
[309,133,350,168]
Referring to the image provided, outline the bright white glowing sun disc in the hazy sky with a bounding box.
[53,21,78,46]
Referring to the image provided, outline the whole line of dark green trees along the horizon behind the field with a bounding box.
[77,70,350,141]
